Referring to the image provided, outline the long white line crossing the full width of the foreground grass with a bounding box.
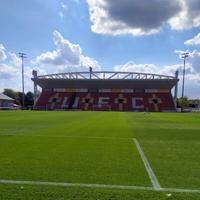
[0,180,200,193]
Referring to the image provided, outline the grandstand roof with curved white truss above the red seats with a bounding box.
[32,71,179,89]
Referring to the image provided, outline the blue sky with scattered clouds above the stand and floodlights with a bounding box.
[0,0,200,99]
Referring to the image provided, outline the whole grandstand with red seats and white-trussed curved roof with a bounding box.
[32,68,179,112]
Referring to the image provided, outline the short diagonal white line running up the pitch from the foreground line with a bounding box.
[133,138,161,190]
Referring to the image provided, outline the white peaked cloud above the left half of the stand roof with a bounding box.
[32,31,100,72]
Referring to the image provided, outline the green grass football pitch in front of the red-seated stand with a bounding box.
[0,111,200,200]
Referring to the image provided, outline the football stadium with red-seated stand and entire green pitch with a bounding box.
[0,69,200,200]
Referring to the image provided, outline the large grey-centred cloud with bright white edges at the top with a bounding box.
[86,0,200,35]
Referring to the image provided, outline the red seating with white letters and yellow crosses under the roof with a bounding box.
[34,91,175,112]
